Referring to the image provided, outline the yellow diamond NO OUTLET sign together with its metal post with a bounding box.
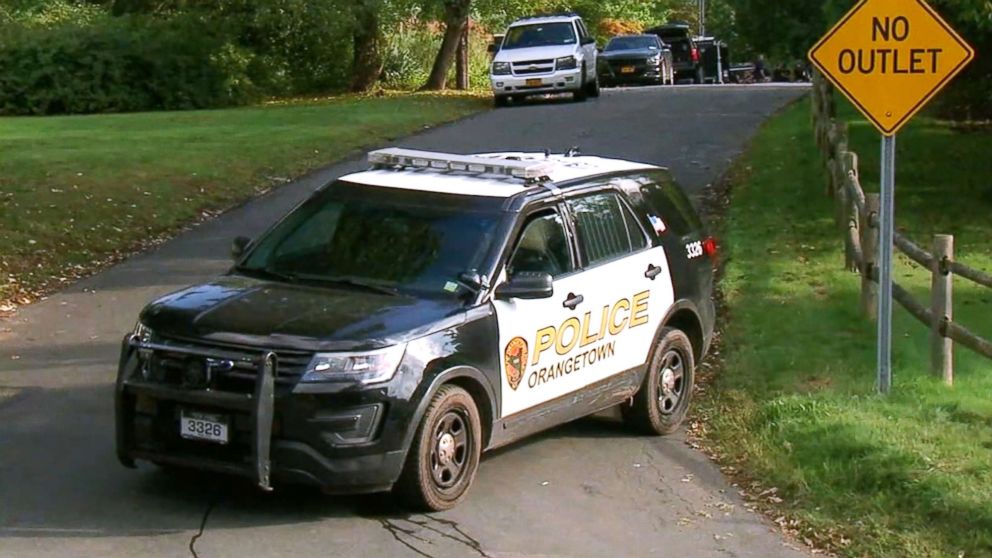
[809,0,975,393]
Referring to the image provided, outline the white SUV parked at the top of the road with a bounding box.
[490,14,599,106]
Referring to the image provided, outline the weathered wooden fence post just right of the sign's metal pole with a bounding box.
[930,234,954,386]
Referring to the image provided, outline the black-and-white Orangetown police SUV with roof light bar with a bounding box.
[116,149,716,510]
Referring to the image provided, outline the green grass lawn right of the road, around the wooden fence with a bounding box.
[701,97,992,557]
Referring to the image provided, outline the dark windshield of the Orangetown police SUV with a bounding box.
[238,181,503,297]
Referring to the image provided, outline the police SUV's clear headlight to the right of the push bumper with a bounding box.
[300,345,406,384]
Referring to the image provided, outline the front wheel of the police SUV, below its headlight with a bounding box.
[394,390,482,511]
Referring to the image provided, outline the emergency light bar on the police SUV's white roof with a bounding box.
[369,148,553,180]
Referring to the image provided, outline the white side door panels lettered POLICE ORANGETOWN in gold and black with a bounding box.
[493,197,674,417]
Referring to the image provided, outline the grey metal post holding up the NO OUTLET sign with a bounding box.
[876,135,896,394]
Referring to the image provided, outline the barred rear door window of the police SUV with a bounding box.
[568,192,647,266]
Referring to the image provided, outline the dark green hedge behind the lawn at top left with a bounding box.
[0,17,258,114]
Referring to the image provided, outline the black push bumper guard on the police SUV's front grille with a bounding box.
[115,335,278,491]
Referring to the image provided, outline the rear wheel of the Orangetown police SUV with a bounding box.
[620,327,696,436]
